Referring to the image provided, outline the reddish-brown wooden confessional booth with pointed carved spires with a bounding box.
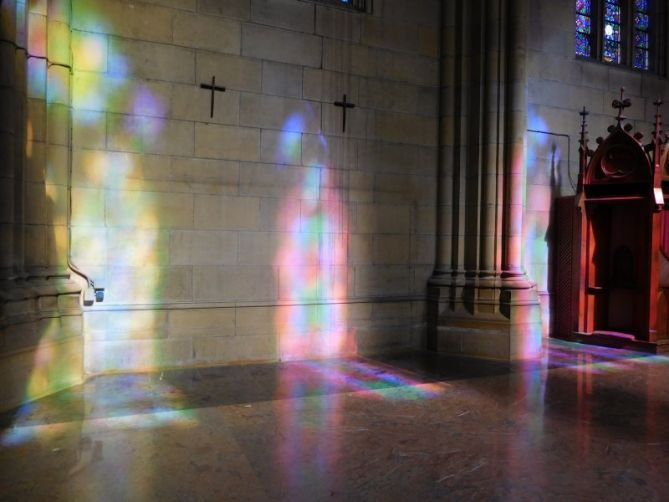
[553,92,669,353]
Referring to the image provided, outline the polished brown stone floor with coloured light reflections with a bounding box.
[0,341,669,501]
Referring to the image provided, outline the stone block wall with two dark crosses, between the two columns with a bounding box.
[71,0,439,373]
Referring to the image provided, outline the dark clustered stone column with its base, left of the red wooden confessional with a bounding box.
[429,0,541,359]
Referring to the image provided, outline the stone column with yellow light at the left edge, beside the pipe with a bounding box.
[0,0,83,410]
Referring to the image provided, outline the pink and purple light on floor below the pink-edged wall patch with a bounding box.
[274,359,448,500]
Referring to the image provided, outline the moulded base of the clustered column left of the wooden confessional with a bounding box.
[428,276,542,361]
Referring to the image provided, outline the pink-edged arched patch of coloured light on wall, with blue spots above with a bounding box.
[274,117,356,360]
